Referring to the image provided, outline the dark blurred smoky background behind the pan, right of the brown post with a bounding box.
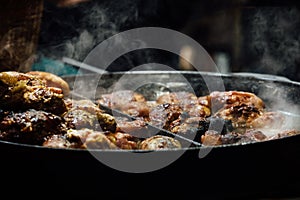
[38,0,300,81]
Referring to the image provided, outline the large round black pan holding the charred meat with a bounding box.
[0,71,300,198]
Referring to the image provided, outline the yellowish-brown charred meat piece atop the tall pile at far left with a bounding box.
[0,72,67,115]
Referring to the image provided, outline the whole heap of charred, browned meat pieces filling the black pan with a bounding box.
[0,71,300,150]
